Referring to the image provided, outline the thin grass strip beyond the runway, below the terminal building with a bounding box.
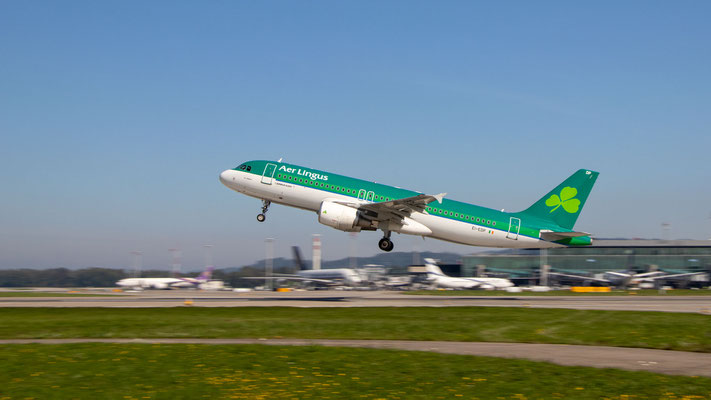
[403,289,711,297]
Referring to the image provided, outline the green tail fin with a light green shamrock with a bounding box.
[521,169,600,229]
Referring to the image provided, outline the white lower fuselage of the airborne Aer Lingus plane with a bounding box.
[220,170,560,248]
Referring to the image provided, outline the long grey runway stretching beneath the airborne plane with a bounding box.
[0,290,711,314]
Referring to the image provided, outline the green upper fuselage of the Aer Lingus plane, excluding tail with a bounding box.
[234,160,580,244]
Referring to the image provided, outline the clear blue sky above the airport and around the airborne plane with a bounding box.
[0,1,711,269]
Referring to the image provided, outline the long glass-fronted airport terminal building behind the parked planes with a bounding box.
[461,239,711,279]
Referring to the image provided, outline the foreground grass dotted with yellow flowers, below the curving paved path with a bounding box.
[0,344,711,400]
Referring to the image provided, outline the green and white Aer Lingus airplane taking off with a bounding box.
[220,159,599,251]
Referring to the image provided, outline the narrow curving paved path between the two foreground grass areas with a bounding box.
[0,339,711,377]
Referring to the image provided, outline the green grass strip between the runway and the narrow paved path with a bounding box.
[0,307,711,352]
